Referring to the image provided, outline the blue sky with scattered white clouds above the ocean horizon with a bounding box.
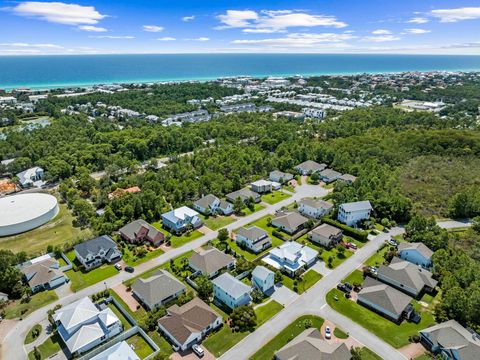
[0,0,480,55]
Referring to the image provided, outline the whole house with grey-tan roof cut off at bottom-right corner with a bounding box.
[420,320,480,360]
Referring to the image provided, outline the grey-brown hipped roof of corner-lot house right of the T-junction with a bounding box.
[358,277,412,315]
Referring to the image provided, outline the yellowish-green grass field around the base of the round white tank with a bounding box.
[0,204,92,255]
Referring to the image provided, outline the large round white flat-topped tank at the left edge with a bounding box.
[0,193,60,236]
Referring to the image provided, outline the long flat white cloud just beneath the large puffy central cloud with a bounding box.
[232,33,355,48]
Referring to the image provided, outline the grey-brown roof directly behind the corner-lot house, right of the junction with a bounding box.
[378,257,437,292]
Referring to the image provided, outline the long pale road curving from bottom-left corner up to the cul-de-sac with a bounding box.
[0,185,328,360]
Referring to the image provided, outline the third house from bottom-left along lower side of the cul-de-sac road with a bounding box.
[188,247,235,278]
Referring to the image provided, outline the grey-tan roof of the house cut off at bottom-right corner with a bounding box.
[420,320,480,360]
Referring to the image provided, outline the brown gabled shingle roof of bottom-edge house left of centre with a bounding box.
[158,298,221,344]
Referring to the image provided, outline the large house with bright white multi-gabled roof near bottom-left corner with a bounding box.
[53,297,123,356]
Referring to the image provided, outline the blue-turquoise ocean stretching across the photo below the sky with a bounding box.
[0,54,480,90]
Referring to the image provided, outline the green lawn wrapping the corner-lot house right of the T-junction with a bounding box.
[327,289,435,348]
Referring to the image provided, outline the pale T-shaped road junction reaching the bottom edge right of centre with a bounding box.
[220,228,405,360]
